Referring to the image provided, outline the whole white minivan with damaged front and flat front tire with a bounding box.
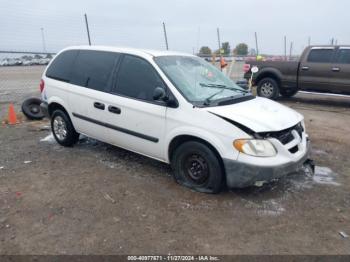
[40,46,309,193]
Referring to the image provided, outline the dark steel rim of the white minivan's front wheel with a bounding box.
[183,154,209,186]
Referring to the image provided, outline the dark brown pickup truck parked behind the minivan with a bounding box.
[244,46,350,99]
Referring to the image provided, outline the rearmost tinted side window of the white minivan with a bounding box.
[46,50,78,82]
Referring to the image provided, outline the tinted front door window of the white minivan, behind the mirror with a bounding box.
[115,55,165,101]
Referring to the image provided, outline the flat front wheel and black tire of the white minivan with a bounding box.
[171,141,224,194]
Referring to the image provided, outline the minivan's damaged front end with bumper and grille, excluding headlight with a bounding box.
[224,117,315,188]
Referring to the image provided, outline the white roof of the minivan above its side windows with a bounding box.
[64,45,193,57]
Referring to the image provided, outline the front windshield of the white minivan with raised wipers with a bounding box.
[155,56,248,105]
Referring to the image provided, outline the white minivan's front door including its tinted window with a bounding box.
[106,55,167,160]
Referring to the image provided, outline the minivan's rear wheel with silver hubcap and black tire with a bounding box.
[51,109,79,146]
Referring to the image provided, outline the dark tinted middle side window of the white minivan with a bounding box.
[70,50,120,91]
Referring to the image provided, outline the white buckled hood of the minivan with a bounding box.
[203,97,303,133]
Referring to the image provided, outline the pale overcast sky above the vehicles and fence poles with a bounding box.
[0,0,350,55]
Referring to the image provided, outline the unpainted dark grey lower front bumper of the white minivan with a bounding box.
[223,142,310,188]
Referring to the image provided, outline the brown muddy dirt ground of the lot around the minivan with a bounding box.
[0,65,350,255]
